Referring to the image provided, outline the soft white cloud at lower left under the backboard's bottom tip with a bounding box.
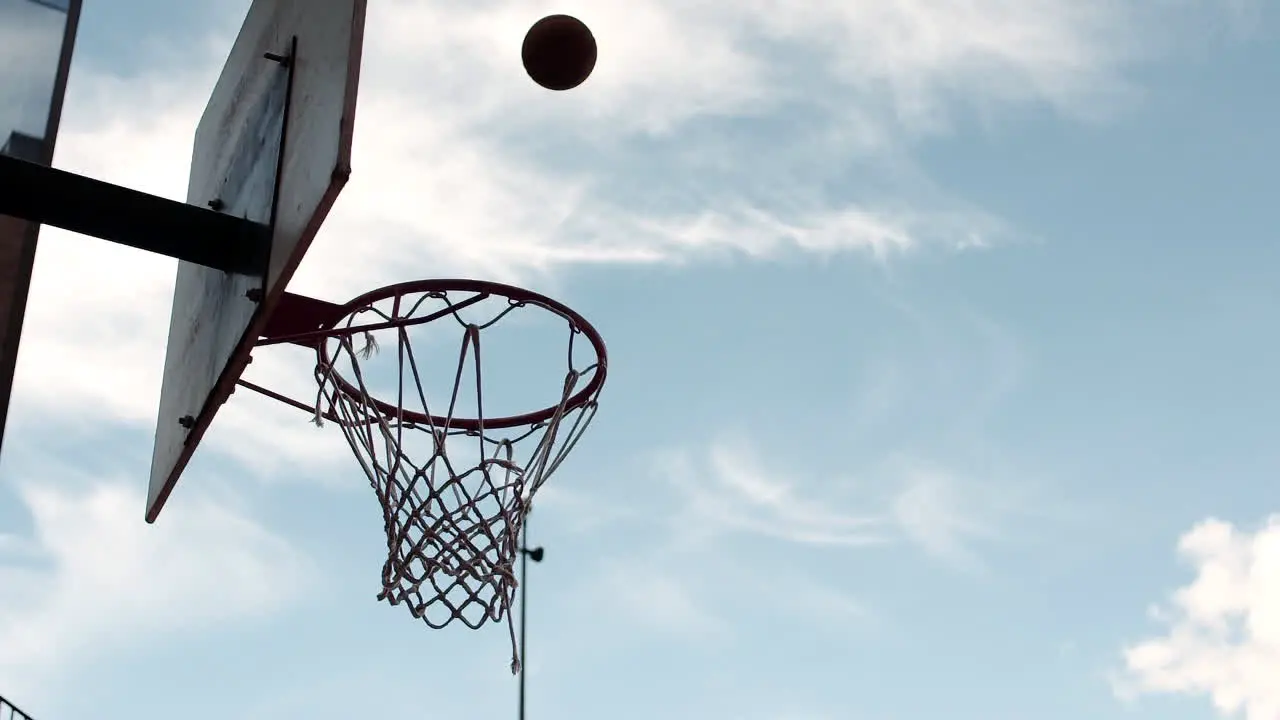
[0,473,312,697]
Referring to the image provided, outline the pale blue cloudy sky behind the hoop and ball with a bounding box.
[0,0,1280,720]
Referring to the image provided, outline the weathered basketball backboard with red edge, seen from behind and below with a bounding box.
[146,0,366,523]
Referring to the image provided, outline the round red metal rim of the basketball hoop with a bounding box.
[316,278,609,430]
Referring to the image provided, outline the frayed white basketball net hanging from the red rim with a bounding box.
[307,286,604,673]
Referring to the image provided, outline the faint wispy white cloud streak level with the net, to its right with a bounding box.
[654,430,1051,571]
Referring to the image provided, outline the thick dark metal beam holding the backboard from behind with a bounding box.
[0,155,271,275]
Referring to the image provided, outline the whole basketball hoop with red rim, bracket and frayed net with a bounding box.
[241,279,607,673]
